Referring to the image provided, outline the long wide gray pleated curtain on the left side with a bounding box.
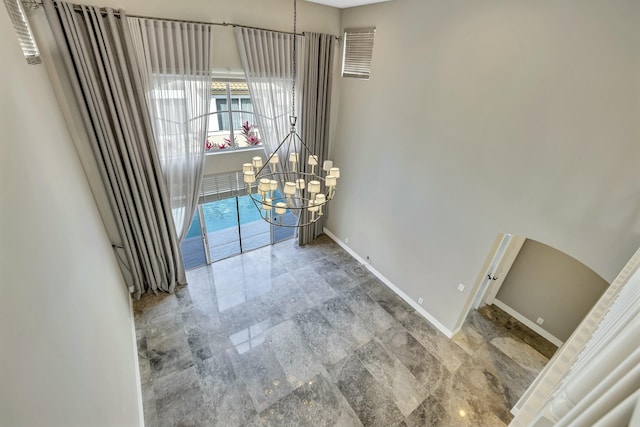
[44,0,186,298]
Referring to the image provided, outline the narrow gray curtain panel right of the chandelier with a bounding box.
[298,33,335,245]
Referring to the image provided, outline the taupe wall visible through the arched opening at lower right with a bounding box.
[496,239,609,341]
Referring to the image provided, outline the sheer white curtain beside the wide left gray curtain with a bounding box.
[129,18,212,241]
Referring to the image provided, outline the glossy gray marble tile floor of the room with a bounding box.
[134,236,547,427]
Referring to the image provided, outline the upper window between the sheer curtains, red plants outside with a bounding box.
[207,80,262,153]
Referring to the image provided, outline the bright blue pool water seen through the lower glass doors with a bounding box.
[186,195,279,239]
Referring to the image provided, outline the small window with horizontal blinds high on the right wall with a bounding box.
[342,28,376,80]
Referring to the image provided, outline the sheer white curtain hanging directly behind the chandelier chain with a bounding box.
[236,27,304,172]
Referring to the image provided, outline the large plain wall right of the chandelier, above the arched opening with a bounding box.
[328,0,640,329]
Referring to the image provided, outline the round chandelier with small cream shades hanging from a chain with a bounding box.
[242,0,340,227]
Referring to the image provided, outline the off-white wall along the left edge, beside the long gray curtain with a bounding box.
[0,7,142,427]
